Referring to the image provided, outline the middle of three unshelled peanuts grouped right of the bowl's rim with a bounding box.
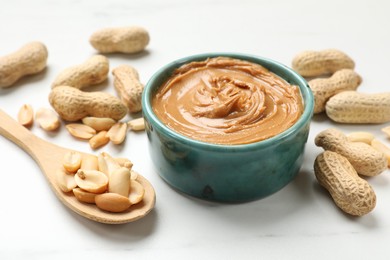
[309,69,362,114]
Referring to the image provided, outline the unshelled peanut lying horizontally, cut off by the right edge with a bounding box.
[325,91,390,124]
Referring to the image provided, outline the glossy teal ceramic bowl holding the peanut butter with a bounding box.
[142,53,314,202]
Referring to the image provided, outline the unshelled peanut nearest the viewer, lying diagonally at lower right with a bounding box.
[314,151,376,216]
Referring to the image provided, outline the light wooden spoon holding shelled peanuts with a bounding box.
[0,109,156,224]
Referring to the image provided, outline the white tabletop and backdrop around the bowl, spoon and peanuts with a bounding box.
[0,0,390,260]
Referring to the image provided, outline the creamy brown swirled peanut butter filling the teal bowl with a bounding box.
[152,57,303,145]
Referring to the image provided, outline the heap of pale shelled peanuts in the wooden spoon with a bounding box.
[56,152,145,212]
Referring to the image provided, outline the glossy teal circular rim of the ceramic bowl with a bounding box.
[142,52,314,151]
